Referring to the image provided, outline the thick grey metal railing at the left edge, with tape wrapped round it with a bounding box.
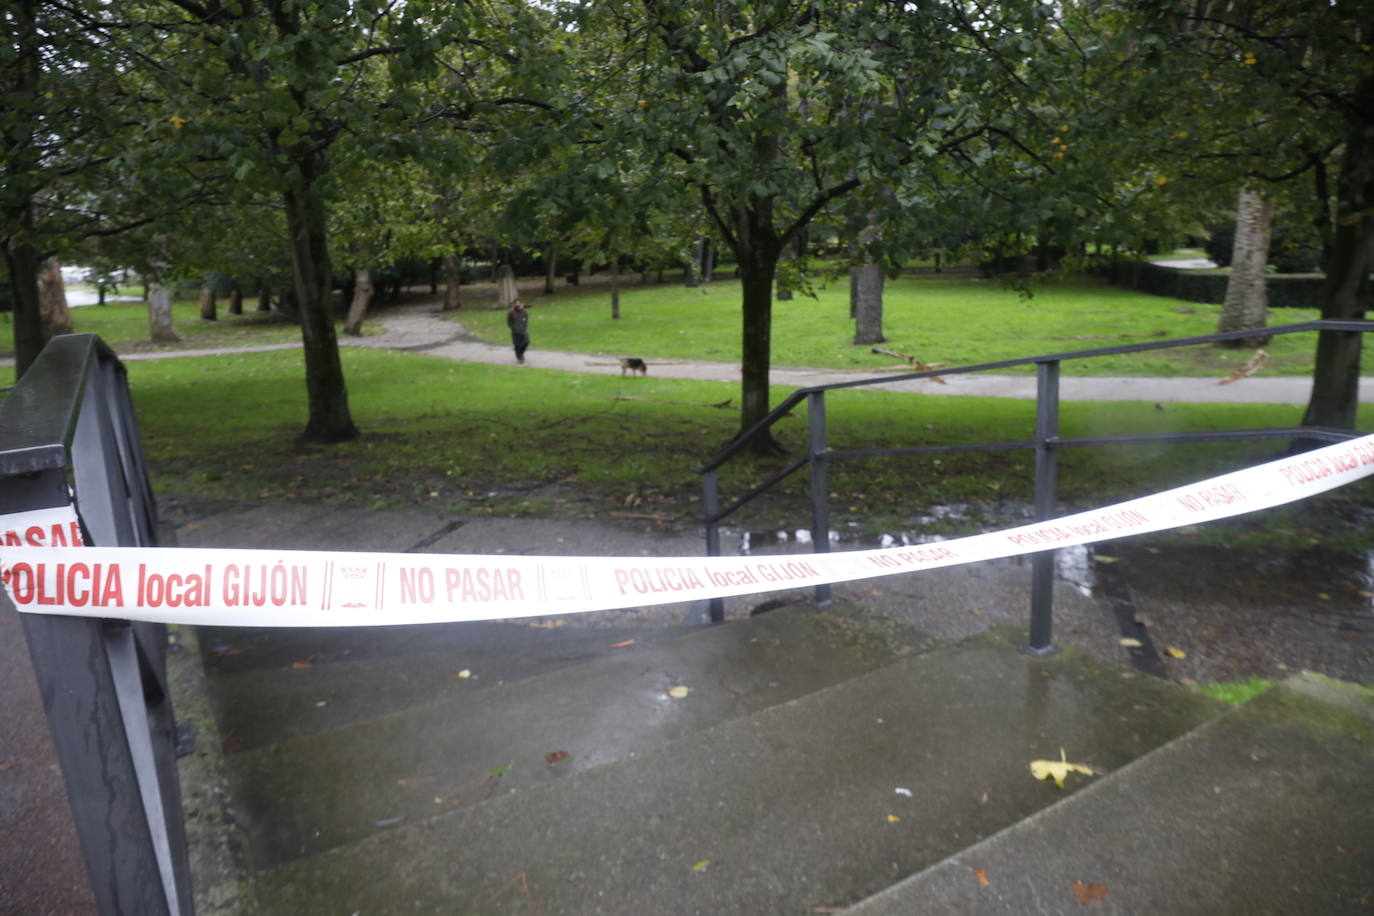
[0,334,192,916]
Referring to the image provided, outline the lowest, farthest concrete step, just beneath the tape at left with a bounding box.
[199,621,697,753]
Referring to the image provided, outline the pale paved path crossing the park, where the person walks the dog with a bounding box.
[13,301,1374,404]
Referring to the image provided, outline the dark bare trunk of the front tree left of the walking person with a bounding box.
[283,152,359,442]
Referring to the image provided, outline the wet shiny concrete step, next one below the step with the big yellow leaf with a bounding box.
[227,606,929,868]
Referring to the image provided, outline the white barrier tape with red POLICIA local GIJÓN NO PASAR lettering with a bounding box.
[0,435,1374,626]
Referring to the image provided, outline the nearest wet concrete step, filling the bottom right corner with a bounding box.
[848,676,1374,916]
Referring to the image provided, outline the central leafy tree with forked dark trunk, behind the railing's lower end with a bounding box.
[570,0,1048,453]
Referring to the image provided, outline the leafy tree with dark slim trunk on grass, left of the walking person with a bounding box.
[128,0,483,442]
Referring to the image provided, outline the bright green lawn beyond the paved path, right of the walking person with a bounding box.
[455,271,1318,378]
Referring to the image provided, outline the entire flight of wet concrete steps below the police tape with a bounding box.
[169,505,1374,916]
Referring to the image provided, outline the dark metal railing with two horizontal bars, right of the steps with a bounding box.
[698,320,1374,655]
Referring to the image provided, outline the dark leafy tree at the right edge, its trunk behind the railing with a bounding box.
[1123,0,1374,428]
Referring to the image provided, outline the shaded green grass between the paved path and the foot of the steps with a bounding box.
[128,347,1374,541]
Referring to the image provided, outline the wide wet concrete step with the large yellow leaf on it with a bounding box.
[247,618,1221,915]
